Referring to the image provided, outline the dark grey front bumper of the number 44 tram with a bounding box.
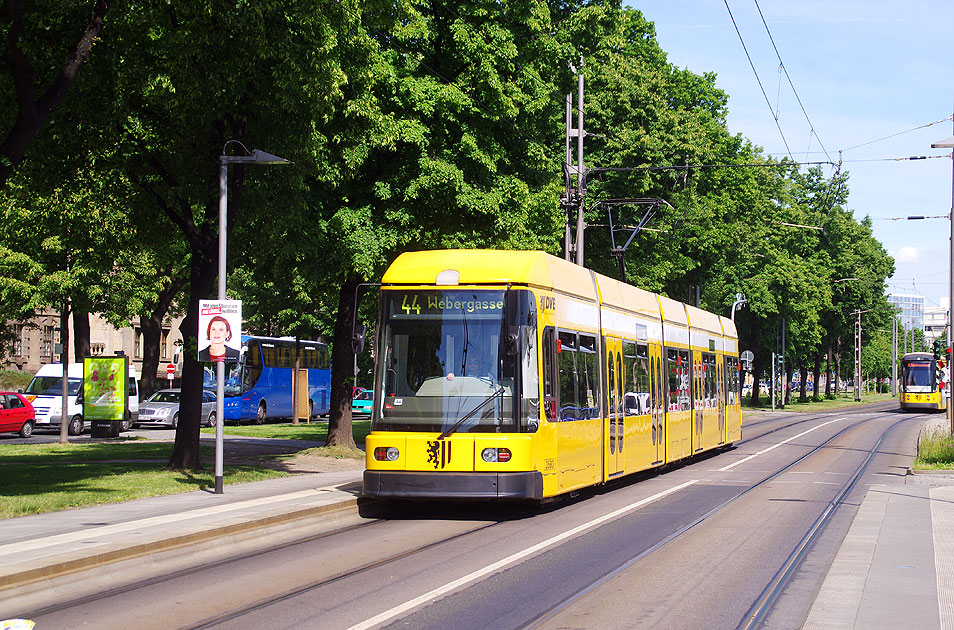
[362,470,543,500]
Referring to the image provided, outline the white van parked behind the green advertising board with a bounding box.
[23,363,139,435]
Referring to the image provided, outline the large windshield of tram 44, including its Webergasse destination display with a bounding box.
[372,288,539,433]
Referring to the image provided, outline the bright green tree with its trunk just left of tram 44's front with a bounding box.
[290,0,566,445]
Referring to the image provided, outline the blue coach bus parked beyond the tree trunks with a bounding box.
[224,335,331,424]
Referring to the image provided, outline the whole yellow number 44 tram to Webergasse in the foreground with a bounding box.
[363,250,742,500]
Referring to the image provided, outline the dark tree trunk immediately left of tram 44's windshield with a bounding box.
[328,276,361,448]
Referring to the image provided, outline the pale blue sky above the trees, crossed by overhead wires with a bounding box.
[629,0,954,306]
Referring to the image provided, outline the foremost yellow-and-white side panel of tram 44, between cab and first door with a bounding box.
[534,286,602,496]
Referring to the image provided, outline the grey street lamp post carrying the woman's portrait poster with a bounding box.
[215,140,294,494]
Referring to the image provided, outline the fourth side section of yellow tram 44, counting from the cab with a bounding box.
[686,305,725,453]
